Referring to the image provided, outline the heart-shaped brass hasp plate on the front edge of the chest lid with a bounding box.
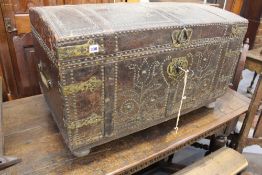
[172,28,193,47]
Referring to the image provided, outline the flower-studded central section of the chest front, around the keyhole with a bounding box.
[112,41,228,133]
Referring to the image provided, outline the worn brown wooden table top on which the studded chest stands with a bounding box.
[1,90,249,175]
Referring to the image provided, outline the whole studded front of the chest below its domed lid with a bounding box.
[58,36,240,147]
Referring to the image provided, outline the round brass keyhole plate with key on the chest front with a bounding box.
[167,57,188,80]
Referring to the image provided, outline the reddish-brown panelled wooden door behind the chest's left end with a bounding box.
[0,0,113,99]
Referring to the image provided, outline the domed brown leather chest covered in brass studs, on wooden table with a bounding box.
[30,3,247,156]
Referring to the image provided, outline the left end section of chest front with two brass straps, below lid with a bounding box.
[60,66,104,149]
